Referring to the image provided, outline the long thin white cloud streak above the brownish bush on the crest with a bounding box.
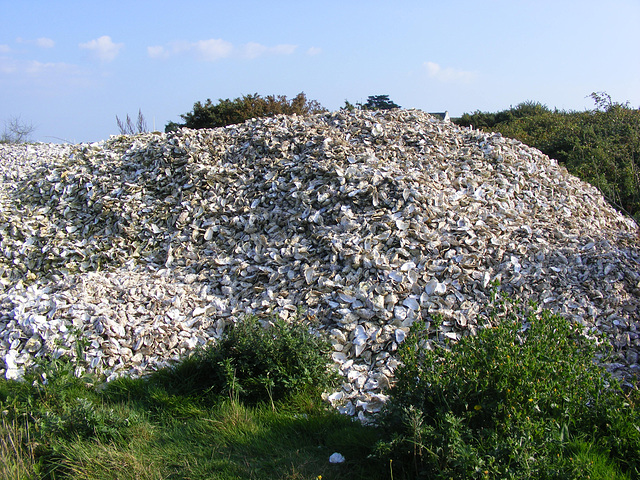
[147,38,297,62]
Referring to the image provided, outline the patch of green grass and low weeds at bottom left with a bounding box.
[0,356,378,479]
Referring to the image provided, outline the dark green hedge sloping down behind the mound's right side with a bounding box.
[456,93,640,219]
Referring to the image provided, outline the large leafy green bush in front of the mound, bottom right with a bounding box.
[378,299,640,479]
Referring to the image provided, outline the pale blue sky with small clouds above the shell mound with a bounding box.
[0,0,640,143]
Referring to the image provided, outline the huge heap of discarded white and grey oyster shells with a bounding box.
[0,110,640,414]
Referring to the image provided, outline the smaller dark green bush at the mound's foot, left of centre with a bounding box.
[148,317,337,403]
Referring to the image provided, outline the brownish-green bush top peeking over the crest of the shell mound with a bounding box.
[165,92,324,132]
